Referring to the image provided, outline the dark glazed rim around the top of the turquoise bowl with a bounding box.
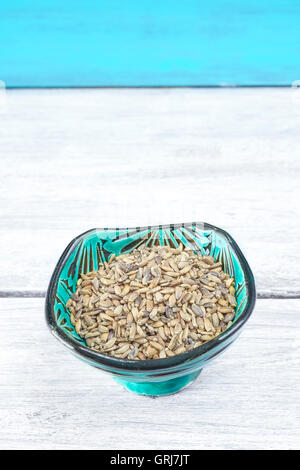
[45,222,256,373]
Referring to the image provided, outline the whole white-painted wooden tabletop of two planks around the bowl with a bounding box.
[0,88,300,449]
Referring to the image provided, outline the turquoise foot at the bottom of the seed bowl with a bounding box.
[114,369,202,397]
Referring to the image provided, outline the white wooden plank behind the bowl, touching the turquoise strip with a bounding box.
[0,89,300,296]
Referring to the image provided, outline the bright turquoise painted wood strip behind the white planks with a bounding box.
[0,0,300,87]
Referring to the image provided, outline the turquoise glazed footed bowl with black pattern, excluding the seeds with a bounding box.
[46,222,256,396]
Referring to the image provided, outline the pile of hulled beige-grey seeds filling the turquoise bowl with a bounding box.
[66,244,236,359]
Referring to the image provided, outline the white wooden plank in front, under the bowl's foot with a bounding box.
[0,299,300,450]
